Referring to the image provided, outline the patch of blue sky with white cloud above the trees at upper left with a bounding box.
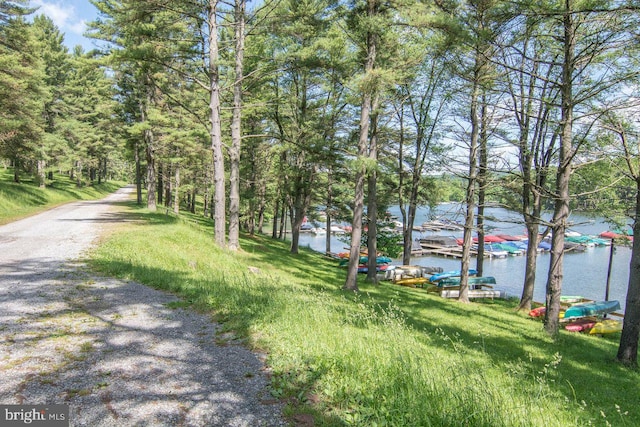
[30,0,98,51]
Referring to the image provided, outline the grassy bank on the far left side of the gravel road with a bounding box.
[0,168,123,225]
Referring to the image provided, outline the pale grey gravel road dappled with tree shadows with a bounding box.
[0,187,287,427]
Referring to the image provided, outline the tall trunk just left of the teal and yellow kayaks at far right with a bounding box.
[545,0,576,336]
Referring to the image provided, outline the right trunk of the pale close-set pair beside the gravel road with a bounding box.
[229,0,246,251]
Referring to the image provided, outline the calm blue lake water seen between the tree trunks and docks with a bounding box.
[300,205,631,310]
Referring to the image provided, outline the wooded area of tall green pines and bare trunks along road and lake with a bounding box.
[0,0,640,364]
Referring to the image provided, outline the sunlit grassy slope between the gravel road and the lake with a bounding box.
[87,205,640,427]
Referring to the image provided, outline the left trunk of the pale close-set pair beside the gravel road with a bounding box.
[208,0,226,248]
